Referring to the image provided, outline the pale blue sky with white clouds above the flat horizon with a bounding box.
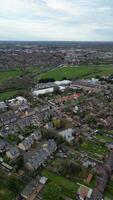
[0,0,113,41]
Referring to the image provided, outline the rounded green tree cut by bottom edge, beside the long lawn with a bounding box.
[43,182,61,200]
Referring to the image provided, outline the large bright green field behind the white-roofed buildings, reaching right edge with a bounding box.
[40,65,113,80]
